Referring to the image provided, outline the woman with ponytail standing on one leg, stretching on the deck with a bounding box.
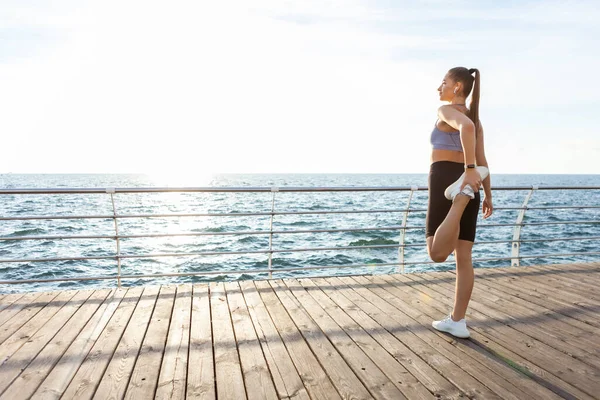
[426,67,493,338]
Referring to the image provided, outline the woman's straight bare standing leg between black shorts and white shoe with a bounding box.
[452,240,475,321]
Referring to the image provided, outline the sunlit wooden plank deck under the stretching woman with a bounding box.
[0,263,600,400]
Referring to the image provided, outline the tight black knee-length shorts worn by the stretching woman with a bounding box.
[425,161,481,242]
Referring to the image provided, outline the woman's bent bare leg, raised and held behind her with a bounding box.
[427,195,473,262]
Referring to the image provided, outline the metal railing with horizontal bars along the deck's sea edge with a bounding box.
[0,186,600,286]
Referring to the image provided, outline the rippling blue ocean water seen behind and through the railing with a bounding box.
[0,174,600,293]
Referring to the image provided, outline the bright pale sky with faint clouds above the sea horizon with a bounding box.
[0,0,600,176]
